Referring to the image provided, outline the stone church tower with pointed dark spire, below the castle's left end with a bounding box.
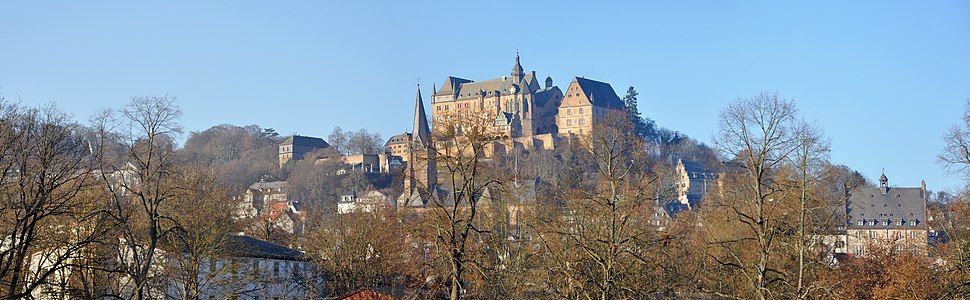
[397,85,438,206]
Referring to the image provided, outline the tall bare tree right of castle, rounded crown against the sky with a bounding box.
[715,93,796,299]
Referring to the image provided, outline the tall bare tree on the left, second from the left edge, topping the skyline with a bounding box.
[95,95,182,299]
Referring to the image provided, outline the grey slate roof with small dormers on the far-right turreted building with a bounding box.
[846,187,927,229]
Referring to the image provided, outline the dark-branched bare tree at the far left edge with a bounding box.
[0,102,107,299]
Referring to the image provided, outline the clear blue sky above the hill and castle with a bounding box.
[0,1,970,190]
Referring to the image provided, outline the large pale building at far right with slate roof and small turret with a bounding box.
[845,174,930,256]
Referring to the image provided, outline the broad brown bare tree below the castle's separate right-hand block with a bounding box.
[536,114,659,299]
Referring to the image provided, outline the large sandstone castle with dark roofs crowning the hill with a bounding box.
[431,54,624,149]
